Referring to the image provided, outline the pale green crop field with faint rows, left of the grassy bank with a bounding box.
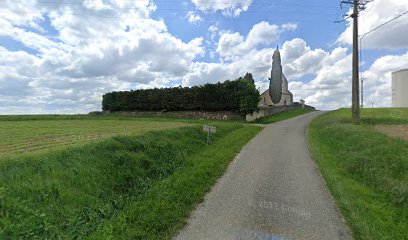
[0,117,189,156]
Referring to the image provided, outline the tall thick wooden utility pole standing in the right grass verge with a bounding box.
[351,0,360,122]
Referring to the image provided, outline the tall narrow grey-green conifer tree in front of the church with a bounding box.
[269,46,283,104]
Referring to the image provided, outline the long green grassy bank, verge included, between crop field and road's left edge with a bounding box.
[0,123,259,239]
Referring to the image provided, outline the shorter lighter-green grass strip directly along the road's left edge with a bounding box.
[92,126,261,239]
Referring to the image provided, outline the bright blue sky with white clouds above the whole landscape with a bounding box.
[0,0,408,114]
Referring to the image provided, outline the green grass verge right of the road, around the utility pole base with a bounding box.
[308,109,408,239]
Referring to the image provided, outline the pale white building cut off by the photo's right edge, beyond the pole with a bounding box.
[392,68,408,107]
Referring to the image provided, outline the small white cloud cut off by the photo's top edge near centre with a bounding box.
[191,0,252,17]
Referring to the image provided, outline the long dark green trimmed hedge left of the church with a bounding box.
[102,73,259,115]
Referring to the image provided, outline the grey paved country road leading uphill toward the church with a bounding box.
[176,112,351,240]
